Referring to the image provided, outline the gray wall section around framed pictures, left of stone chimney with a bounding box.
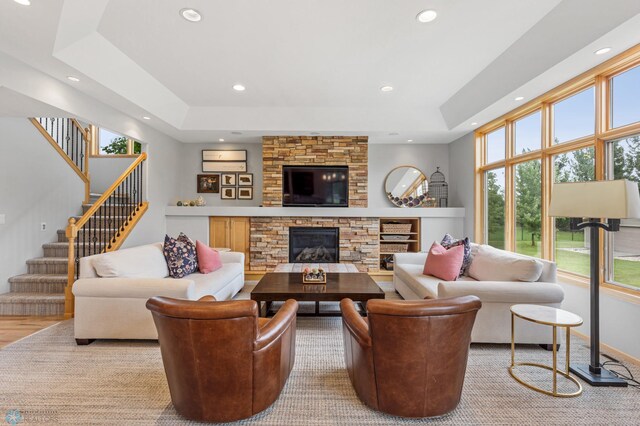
[178,143,262,207]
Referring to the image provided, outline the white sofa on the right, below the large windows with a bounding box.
[393,248,564,345]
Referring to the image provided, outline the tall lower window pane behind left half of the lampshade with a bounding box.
[553,147,596,276]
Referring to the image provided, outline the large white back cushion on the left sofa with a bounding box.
[91,244,169,278]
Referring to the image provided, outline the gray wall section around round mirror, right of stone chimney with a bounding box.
[369,144,451,208]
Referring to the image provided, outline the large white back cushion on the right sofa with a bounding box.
[469,245,542,282]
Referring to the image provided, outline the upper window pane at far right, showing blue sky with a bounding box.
[611,66,640,128]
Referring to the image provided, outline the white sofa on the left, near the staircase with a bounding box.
[73,243,244,343]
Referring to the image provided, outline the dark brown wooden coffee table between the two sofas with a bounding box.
[251,272,384,316]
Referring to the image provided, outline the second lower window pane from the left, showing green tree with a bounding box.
[515,160,542,257]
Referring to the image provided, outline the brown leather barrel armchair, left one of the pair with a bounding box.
[147,297,298,422]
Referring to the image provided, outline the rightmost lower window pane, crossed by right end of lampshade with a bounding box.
[607,135,640,288]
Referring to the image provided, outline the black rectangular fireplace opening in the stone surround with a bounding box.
[289,226,340,263]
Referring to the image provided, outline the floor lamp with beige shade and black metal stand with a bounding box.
[549,179,640,386]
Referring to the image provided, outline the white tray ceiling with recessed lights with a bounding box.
[0,0,640,143]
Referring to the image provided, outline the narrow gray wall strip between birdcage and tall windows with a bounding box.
[449,132,475,241]
